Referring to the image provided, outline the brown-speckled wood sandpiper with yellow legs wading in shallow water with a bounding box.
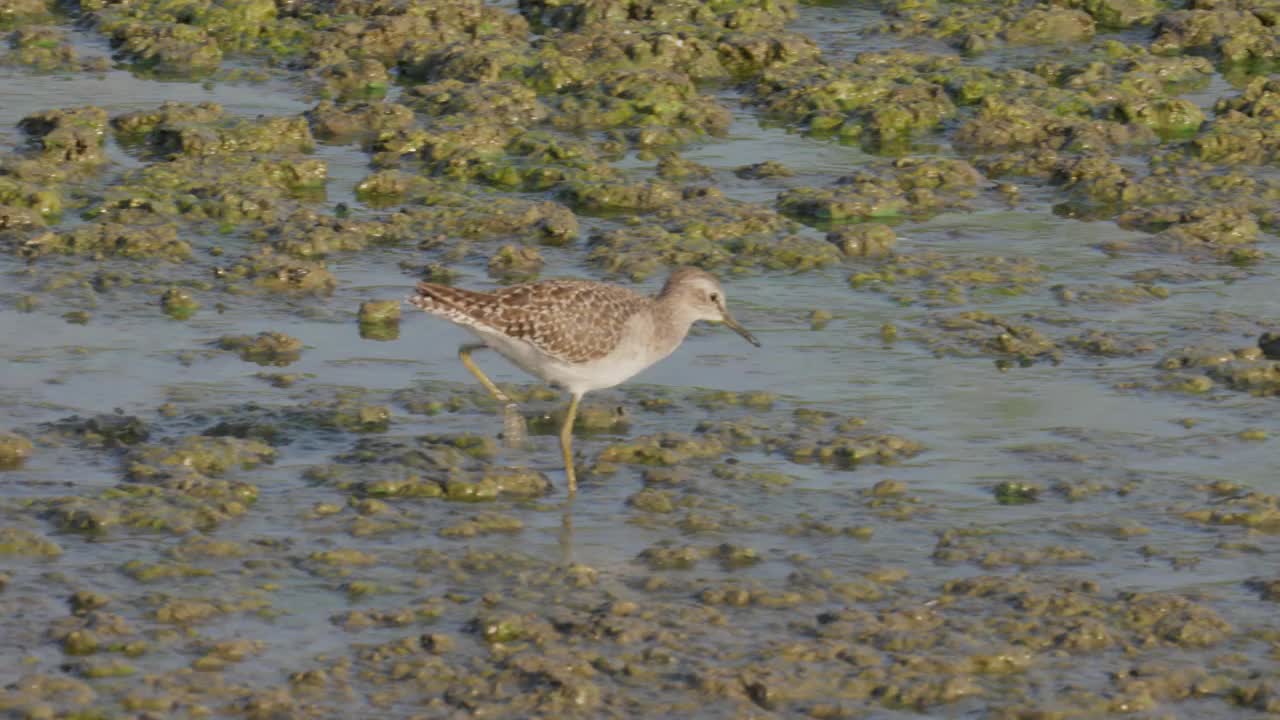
[410,268,760,493]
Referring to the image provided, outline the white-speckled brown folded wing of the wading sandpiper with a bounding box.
[410,281,650,363]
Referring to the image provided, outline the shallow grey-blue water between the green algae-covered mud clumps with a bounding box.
[0,2,1280,716]
